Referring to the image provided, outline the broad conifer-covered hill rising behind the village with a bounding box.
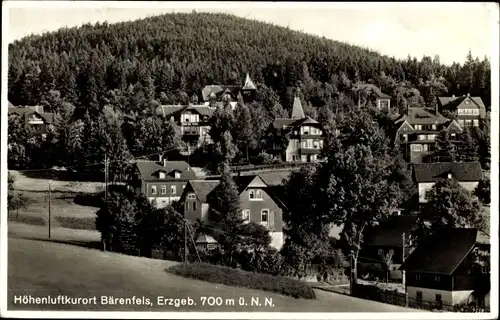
[8,12,490,112]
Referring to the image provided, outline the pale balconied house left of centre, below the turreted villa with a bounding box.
[156,105,216,156]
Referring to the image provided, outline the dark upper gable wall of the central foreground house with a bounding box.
[240,188,283,232]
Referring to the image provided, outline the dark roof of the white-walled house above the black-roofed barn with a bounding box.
[413,162,483,182]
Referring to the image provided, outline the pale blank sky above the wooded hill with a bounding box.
[2,1,499,64]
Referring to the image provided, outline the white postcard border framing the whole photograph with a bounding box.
[0,1,500,319]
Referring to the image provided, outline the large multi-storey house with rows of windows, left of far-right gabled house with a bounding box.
[394,107,462,163]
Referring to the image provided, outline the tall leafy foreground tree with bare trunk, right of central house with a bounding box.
[317,142,401,290]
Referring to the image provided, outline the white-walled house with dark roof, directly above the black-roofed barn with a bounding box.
[413,162,483,203]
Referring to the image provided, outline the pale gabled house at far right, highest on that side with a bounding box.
[438,94,486,128]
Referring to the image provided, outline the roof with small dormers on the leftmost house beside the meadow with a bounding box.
[136,161,196,181]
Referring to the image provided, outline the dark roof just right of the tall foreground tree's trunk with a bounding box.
[364,215,417,246]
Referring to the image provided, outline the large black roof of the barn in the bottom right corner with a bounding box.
[400,228,477,275]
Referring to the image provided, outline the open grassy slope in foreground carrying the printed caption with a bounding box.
[8,223,422,312]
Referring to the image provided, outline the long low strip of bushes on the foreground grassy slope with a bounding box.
[168,263,316,299]
